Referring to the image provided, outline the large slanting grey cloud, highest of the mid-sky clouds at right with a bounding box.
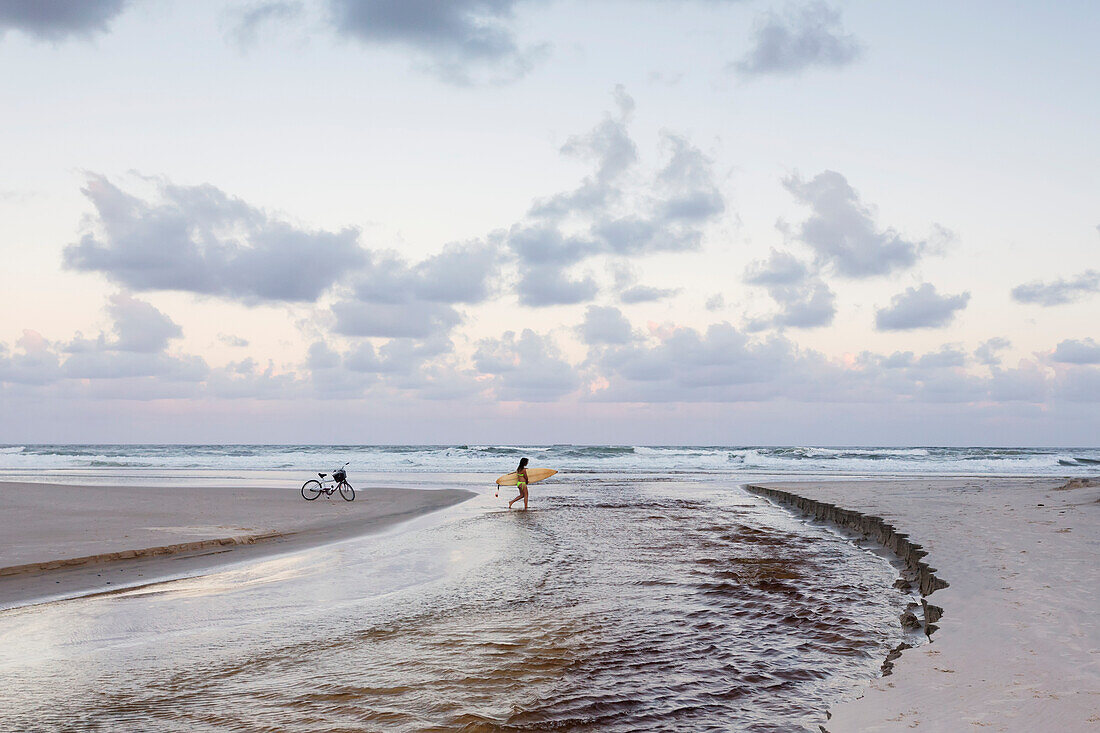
[783,171,928,278]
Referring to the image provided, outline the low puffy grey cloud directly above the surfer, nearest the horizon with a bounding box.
[474,329,581,402]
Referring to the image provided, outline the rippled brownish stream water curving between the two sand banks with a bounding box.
[0,481,903,731]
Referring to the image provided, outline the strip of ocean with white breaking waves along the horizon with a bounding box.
[0,445,1100,480]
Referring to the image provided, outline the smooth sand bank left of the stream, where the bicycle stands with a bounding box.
[0,483,473,608]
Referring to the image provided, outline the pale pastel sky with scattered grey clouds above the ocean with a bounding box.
[0,0,1100,446]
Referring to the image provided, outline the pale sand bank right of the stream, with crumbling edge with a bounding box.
[750,479,1100,733]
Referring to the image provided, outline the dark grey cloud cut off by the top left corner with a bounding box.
[0,0,127,41]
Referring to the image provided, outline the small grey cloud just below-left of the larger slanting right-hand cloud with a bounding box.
[745,250,836,330]
